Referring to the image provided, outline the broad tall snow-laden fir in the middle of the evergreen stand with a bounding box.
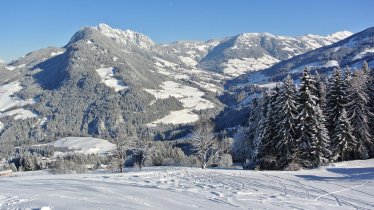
[298,68,330,167]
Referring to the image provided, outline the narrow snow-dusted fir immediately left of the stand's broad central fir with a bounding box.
[275,75,299,168]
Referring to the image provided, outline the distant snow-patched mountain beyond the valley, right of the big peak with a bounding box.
[198,31,352,76]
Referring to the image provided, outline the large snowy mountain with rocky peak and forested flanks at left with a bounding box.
[0,24,224,140]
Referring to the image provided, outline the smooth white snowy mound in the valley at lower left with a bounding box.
[49,137,115,155]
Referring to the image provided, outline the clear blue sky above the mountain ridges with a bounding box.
[0,0,374,62]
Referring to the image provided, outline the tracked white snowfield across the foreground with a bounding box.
[0,159,374,210]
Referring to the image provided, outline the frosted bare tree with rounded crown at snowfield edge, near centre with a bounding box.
[192,120,221,169]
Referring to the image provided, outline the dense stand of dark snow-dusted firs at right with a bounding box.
[234,62,374,170]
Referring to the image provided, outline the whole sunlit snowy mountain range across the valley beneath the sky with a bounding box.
[0,24,366,141]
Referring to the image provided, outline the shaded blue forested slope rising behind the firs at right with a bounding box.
[241,28,374,84]
